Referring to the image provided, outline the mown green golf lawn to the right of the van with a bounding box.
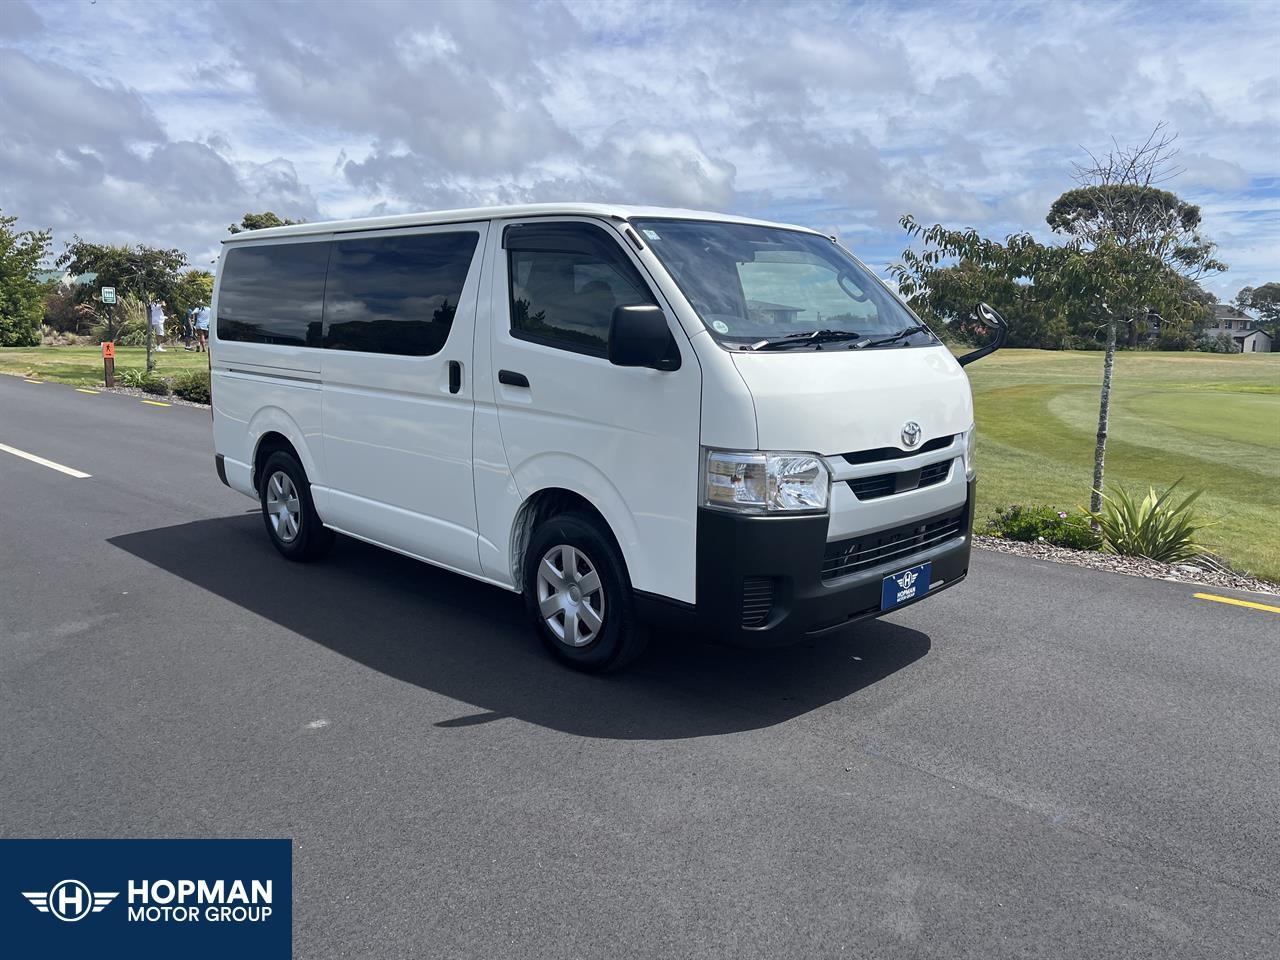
[968,349,1280,580]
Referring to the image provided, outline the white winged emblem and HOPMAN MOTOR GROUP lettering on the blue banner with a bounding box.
[22,879,271,923]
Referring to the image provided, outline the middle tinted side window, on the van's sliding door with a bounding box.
[324,233,480,357]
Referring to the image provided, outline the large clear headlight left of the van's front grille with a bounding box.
[703,451,831,513]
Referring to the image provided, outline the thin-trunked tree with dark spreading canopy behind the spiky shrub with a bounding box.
[891,124,1226,513]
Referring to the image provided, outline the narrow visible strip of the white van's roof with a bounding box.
[223,204,820,243]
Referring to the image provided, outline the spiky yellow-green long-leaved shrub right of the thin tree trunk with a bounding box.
[1089,480,1212,563]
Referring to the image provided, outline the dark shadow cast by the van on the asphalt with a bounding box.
[109,512,929,740]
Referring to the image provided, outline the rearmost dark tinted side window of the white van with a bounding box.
[218,241,329,347]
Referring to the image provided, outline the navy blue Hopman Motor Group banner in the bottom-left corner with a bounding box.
[0,840,293,960]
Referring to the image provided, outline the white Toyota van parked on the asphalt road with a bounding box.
[211,204,1004,671]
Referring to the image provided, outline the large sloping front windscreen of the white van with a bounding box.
[632,219,937,349]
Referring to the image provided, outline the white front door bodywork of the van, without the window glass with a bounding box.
[476,218,701,603]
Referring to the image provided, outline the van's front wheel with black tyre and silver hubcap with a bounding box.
[524,512,648,673]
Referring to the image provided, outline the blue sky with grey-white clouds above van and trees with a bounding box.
[0,0,1280,298]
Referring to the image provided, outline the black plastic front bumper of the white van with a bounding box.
[645,480,974,646]
